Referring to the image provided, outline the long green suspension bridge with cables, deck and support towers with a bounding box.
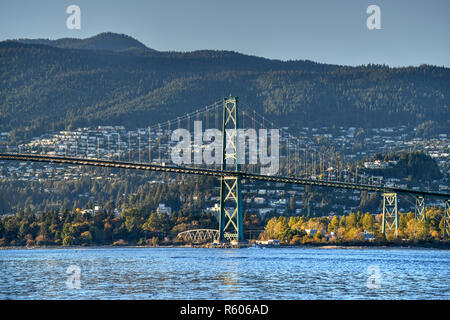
[0,97,450,242]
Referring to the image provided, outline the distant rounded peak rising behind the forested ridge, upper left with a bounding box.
[16,32,156,51]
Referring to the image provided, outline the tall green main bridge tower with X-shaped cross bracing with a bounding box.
[219,97,244,242]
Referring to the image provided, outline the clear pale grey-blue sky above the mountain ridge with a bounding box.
[0,0,450,67]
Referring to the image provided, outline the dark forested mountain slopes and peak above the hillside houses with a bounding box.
[0,33,450,140]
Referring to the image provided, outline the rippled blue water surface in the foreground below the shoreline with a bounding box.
[0,248,450,299]
